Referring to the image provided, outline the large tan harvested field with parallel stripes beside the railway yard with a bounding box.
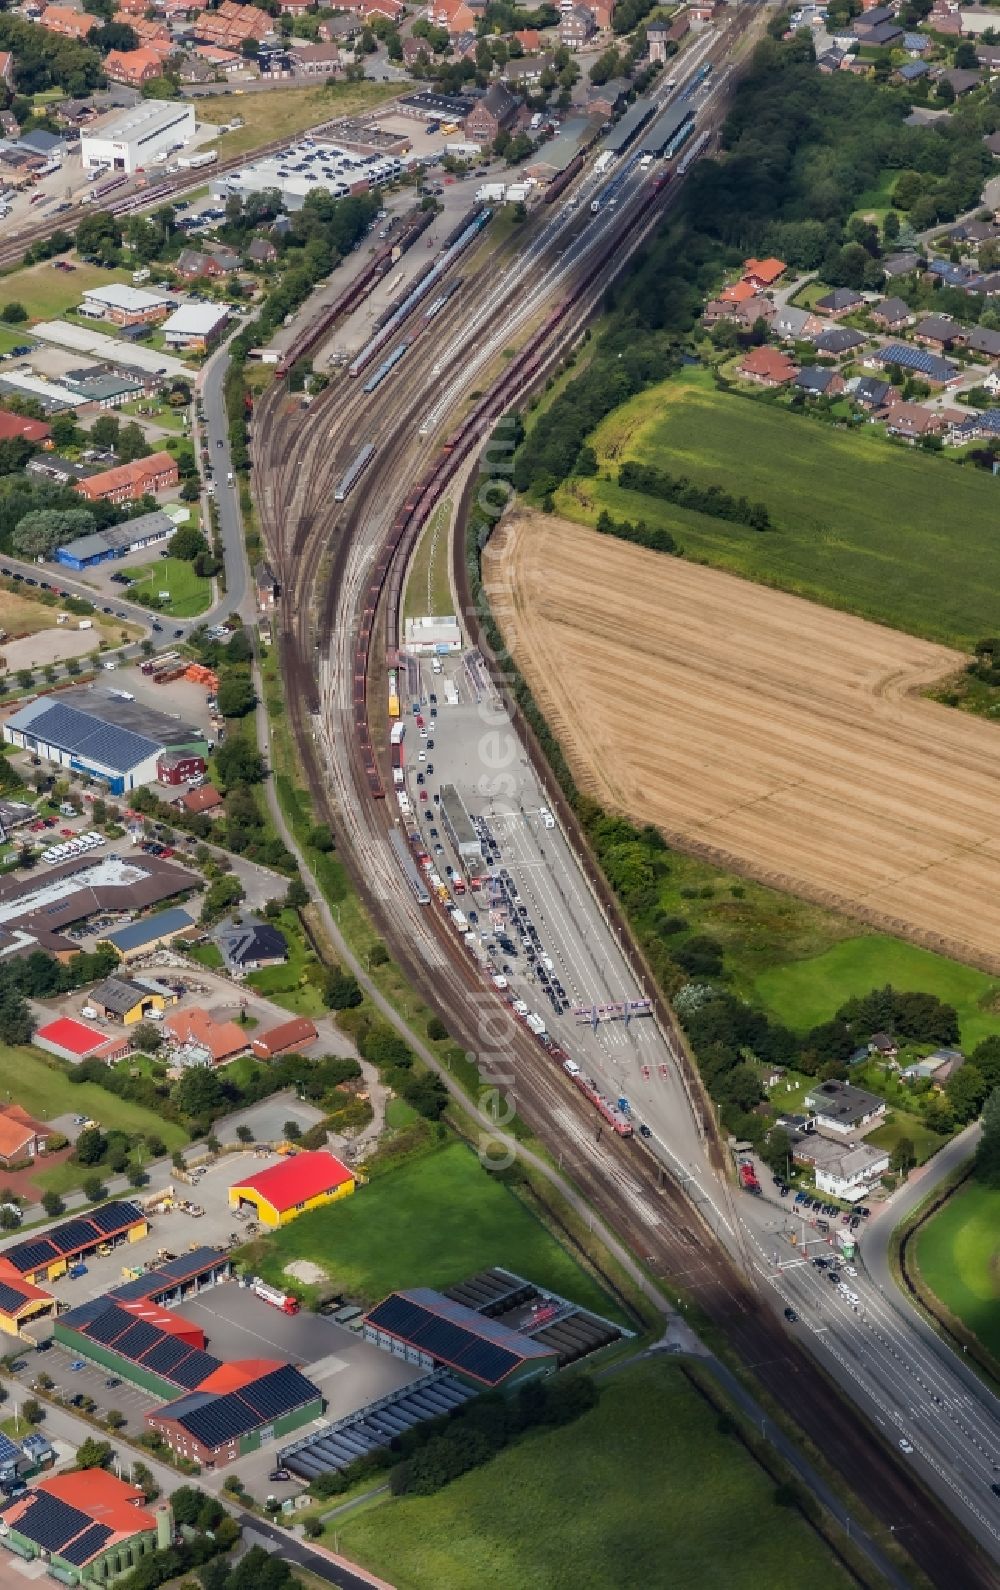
[485,514,1000,971]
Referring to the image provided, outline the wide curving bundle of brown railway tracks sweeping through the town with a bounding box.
[254,24,1000,1590]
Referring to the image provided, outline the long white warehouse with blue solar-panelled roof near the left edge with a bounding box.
[3,687,208,795]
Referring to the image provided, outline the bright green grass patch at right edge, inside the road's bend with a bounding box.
[916,1181,1000,1358]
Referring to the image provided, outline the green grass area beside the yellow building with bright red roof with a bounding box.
[240,1143,617,1317]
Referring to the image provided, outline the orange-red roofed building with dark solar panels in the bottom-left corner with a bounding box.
[2,1469,162,1585]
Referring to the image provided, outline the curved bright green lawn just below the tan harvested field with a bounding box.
[755,933,1000,1049]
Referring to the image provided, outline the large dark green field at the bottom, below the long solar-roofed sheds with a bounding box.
[335,1359,851,1590]
